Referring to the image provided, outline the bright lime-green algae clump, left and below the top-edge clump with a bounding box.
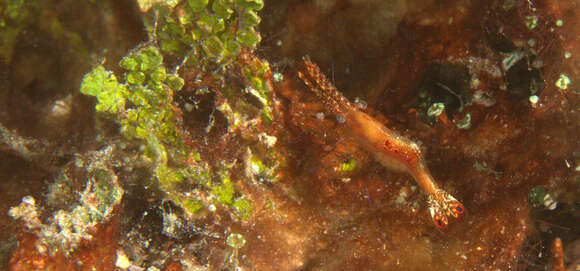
[81,46,195,199]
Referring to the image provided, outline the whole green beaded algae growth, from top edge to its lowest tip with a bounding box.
[80,0,273,224]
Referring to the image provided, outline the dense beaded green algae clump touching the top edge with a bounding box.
[148,0,264,64]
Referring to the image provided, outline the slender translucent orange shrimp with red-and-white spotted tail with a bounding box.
[298,57,465,229]
